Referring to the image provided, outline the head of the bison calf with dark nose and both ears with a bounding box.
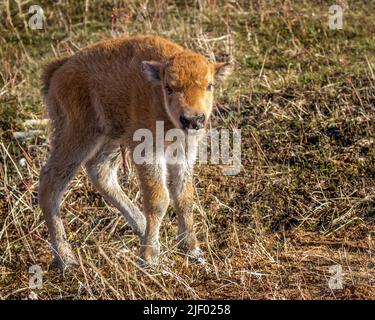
[142,51,233,131]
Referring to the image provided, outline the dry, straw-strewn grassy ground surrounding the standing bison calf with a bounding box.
[0,0,375,299]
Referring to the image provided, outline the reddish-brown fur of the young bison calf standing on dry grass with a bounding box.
[39,36,231,267]
